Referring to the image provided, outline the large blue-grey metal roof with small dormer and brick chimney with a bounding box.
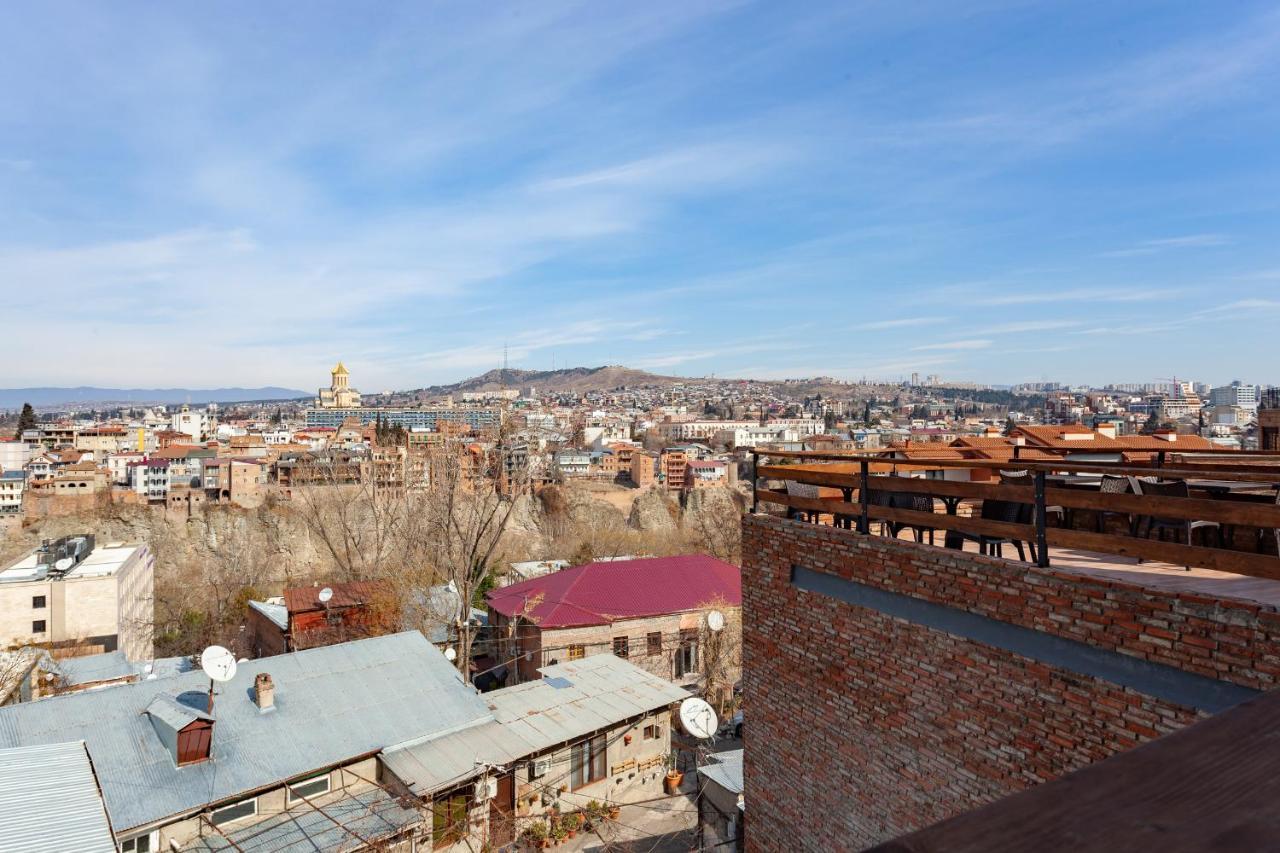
[0,631,489,831]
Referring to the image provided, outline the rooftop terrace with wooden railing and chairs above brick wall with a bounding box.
[753,444,1280,596]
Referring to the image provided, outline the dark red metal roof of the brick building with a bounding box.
[488,555,742,628]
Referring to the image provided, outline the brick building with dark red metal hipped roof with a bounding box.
[488,555,742,686]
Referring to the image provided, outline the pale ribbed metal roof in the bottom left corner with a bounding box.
[0,742,115,853]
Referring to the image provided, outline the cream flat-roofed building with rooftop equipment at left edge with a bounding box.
[0,534,155,661]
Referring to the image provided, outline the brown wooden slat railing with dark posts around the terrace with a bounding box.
[753,447,1280,579]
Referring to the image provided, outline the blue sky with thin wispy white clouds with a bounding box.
[0,0,1280,391]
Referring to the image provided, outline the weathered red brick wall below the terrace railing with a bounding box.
[742,515,1280,850]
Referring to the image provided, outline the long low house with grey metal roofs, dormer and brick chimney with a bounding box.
[0,631,686,853]
